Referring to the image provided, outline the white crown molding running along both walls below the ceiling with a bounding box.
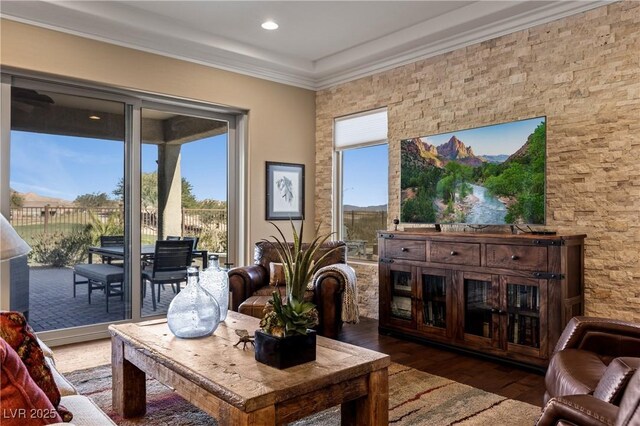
[0,0,614,90]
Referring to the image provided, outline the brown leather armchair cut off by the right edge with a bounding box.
[544,317,640,405]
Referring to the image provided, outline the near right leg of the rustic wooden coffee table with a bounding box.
[341,368,389,426]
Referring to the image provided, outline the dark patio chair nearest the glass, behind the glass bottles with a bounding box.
[142,240,193,311]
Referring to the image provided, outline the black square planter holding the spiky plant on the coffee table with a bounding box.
[255,330,316,369]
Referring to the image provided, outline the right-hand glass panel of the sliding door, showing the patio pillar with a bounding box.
[140,104,229,316]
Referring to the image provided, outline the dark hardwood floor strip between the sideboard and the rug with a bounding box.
[339,318,544,406]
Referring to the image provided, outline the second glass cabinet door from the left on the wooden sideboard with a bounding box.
[420,269,447,329]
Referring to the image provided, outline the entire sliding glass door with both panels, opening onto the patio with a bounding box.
[0,74,244,344]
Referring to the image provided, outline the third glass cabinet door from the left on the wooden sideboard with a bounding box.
[464,278,495,339]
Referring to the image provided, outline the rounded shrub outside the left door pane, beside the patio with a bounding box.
[29,230,91,268]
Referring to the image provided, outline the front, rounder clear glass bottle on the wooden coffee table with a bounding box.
[167,267,220,339]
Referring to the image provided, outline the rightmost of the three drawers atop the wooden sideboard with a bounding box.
[487,244,547,272]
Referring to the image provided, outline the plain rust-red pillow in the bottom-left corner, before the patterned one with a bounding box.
[0,339,62,426]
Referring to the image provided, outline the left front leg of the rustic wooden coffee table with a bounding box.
[111,336,147,418]
